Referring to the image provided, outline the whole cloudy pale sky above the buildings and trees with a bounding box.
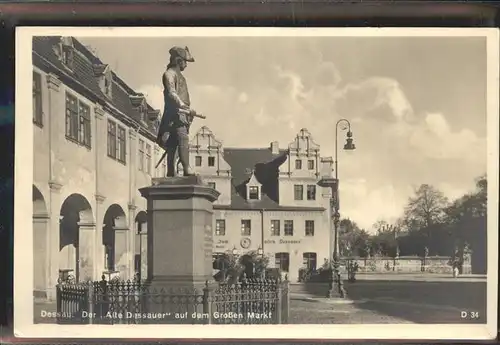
[78,37,487,231]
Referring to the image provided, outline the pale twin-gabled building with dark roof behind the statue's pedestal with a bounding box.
[190,127,332,281]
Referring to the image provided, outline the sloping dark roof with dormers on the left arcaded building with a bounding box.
[33,36,156,139]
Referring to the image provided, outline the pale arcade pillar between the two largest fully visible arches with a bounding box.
[78,222,96,282]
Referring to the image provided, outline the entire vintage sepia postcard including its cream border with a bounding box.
[14,27,500,339]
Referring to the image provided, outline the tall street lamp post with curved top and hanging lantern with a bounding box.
[318,119,356,298]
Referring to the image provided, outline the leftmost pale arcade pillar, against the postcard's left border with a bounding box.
[33,214,51,298]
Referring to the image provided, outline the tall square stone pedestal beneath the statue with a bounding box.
[140,176,219,323]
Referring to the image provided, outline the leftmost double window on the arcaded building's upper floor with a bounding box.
[66,93,91,148]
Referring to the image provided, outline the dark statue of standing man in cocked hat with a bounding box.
[157,47,196,177]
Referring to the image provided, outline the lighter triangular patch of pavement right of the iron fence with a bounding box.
[289,298,412,324]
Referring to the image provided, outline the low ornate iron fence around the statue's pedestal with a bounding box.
[57,278,289,324]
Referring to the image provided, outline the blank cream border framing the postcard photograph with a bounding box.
[14,27,500,340]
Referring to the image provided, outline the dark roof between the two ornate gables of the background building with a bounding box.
[219,148,324,211]
